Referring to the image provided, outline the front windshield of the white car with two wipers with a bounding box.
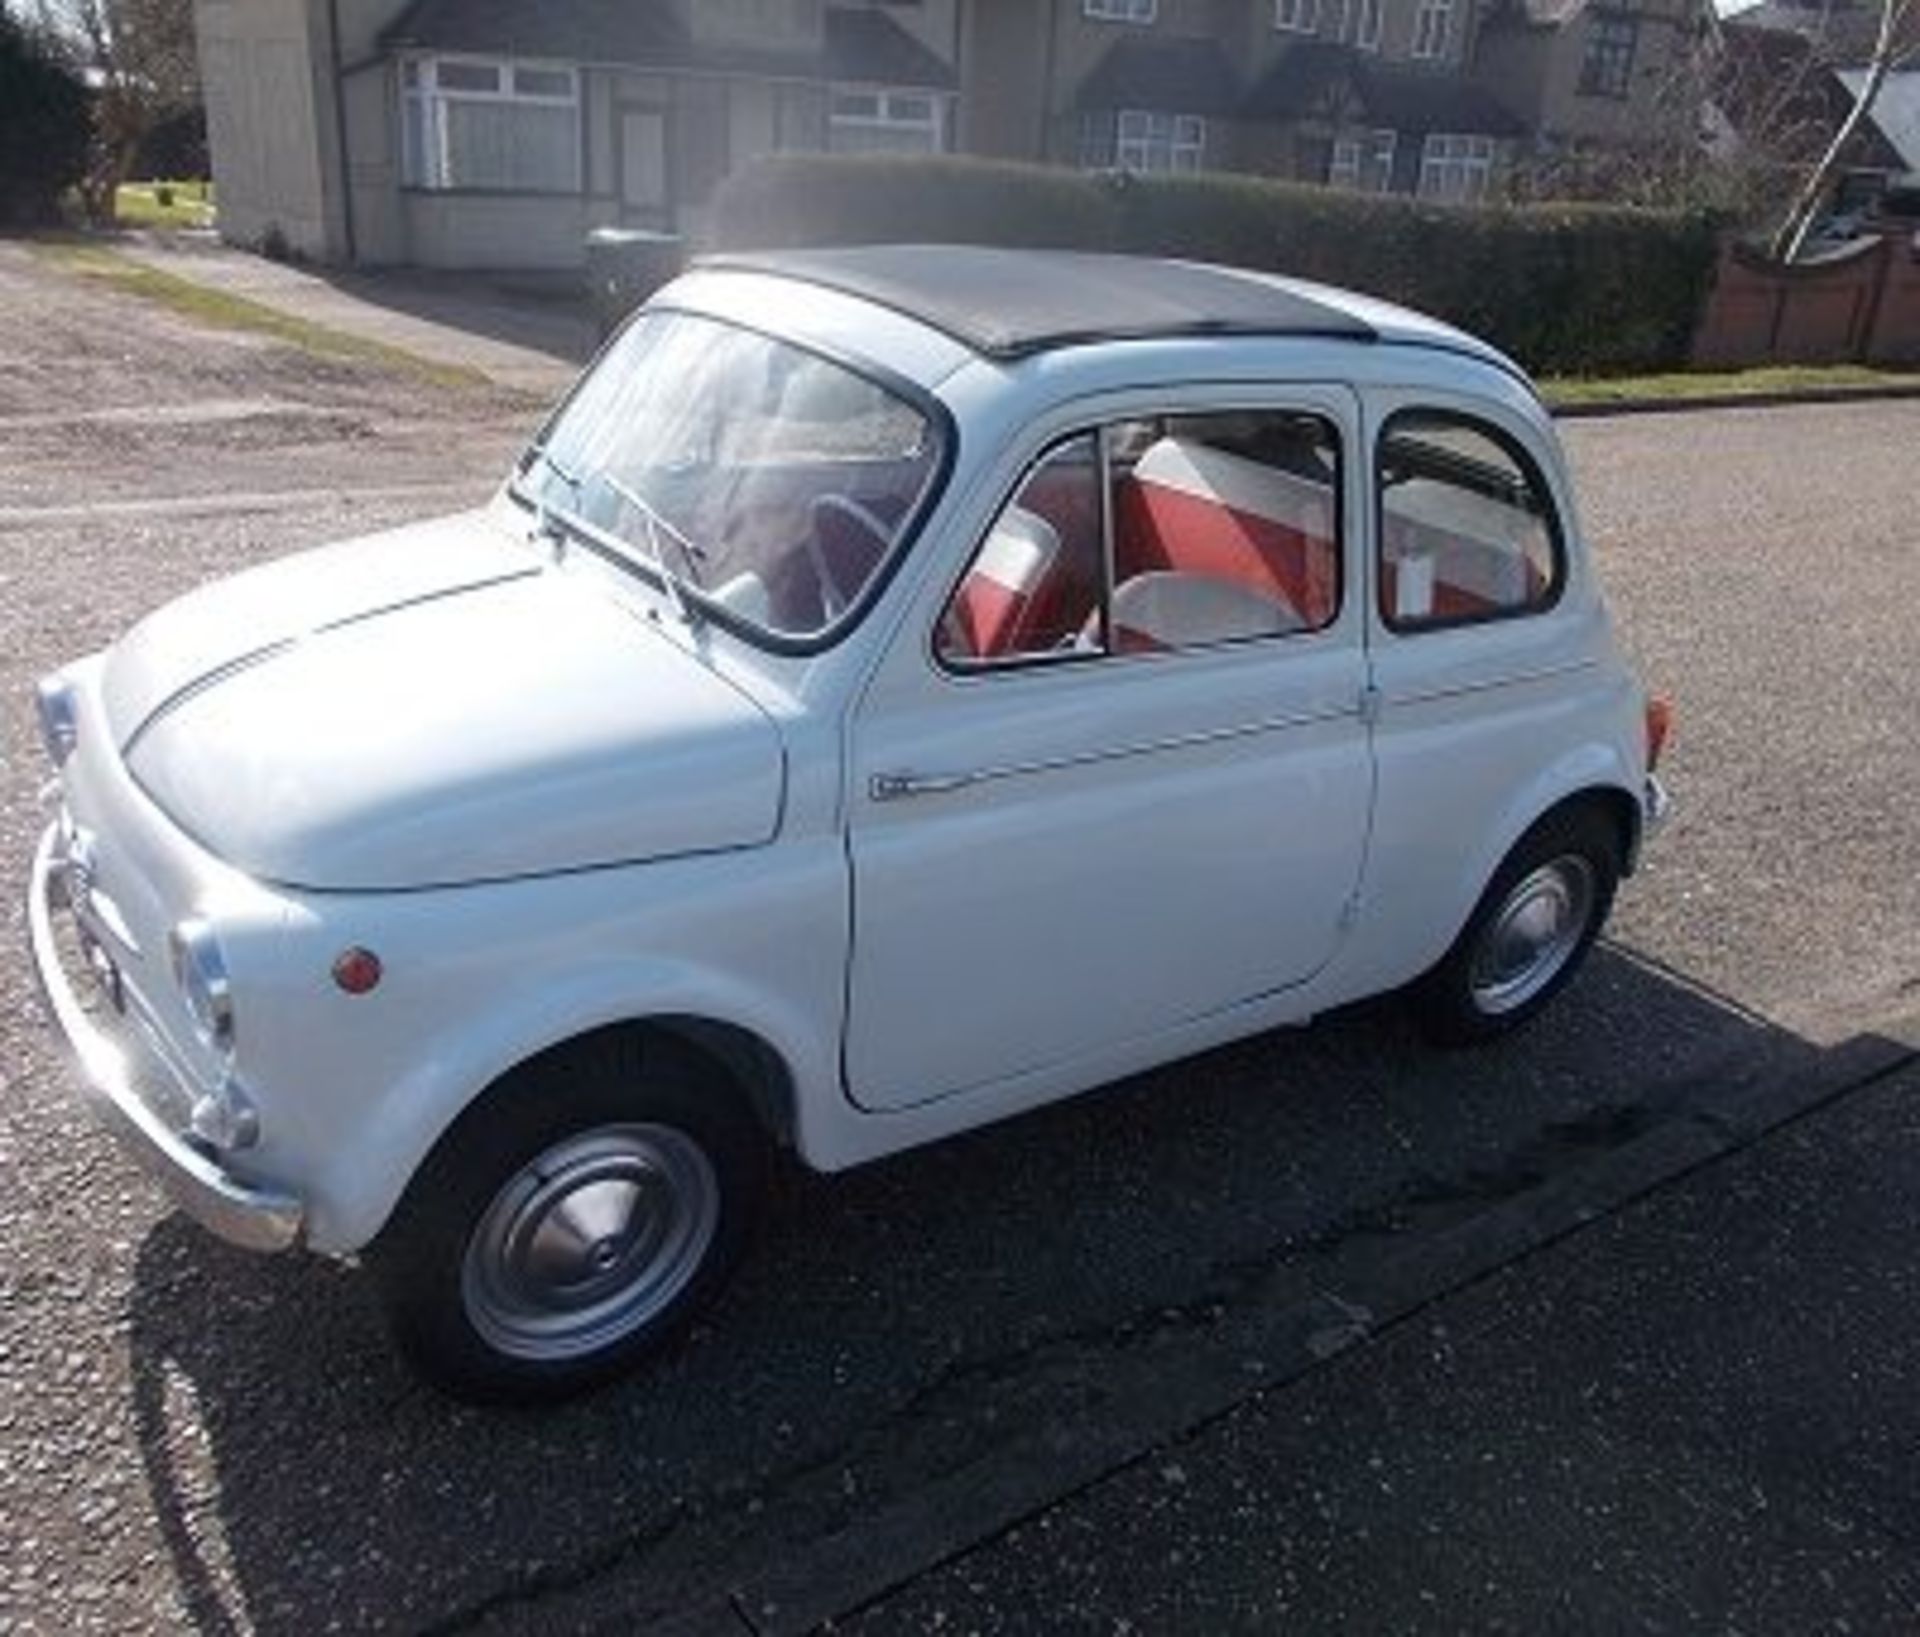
[515,311,941,641]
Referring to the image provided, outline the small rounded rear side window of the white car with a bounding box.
[1379,409,1565,631]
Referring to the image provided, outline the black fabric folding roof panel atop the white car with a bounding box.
[699,244,1379,361]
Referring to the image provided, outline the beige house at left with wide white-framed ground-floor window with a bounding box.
[194,0,960,269]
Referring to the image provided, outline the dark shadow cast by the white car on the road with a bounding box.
[120,948,1904,1631]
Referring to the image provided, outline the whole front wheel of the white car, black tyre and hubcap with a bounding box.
[367,1031,768,1403]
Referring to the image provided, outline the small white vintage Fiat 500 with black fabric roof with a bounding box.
[29,248,1665,1397]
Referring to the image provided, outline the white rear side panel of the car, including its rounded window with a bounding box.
[1356,390,1612,963]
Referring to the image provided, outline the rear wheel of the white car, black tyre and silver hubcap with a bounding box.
[1409,804,1620,1046]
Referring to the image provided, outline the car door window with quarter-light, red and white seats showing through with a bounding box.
[935,411,1340,668]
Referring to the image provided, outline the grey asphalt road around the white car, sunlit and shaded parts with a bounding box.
[0,246,1920,1631]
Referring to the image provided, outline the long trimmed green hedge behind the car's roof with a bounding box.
[712,155,1718,374]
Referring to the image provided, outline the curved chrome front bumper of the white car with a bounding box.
[27,825,305,1251]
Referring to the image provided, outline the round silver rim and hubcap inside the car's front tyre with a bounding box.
[461,1125,720,1361]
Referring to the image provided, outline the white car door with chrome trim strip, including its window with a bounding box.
[845,390,1371,1109]
